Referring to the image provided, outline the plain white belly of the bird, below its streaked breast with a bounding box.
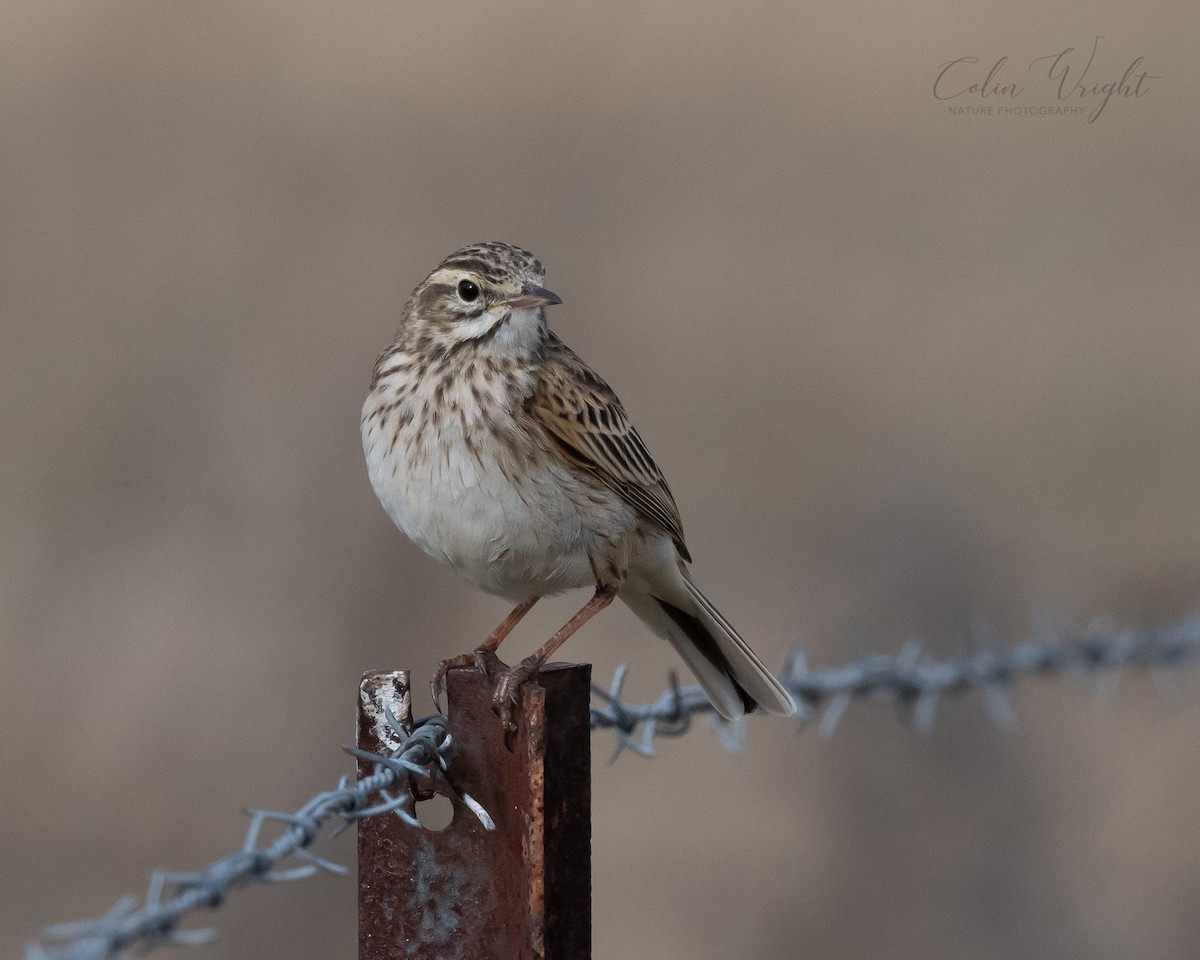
[362,398,636,601]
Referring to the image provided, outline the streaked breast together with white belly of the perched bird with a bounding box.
[362,360,636,600]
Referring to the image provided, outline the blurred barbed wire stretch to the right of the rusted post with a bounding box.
[592,613,1200,758]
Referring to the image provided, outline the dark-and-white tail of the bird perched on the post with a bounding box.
[620,570,796,720]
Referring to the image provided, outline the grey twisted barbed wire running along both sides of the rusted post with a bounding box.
[25,613,1200,960]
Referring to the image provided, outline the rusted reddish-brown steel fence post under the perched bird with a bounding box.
[359,664,592,960]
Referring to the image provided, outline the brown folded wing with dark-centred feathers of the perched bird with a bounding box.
[527,337,691,560]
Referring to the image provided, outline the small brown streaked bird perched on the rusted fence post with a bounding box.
[361,241,796,732]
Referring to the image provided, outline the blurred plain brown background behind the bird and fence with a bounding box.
[0,0,1200,960]
